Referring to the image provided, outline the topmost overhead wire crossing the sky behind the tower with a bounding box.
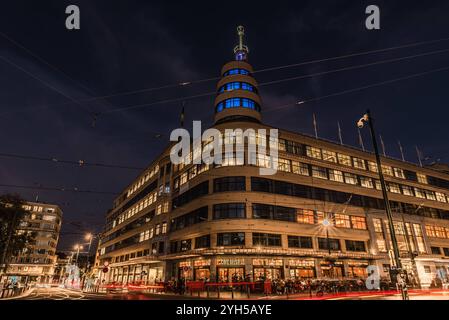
[0,38,449,116]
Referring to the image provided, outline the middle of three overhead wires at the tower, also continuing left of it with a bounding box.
[93,49,449,114]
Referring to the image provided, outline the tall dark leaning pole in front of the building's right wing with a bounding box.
[358,110,408,300]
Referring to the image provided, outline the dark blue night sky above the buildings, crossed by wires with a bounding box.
[0,0,449,250]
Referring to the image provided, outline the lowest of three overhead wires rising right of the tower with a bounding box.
[264,66,449,112]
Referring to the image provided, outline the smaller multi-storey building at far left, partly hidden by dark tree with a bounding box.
[2,202,62,283]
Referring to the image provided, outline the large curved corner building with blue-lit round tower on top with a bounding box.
[97,26,449,286]
